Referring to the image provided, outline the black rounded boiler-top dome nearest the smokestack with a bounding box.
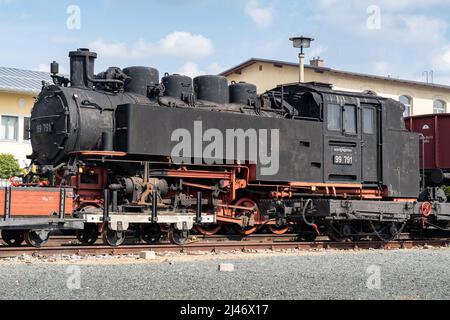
[123,67,159,96]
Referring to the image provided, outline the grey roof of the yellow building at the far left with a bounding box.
[0,67,53,94]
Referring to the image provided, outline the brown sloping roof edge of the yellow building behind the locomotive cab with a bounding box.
[220,58,450,90]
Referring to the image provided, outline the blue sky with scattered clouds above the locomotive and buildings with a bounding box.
[0,0,450,85]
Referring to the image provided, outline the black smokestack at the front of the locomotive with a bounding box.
[69,49,97,88]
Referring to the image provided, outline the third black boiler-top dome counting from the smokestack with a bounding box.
[194,76,229,104]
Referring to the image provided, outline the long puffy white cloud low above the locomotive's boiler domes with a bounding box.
[90,31,214,59]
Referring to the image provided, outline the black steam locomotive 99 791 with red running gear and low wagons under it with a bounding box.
[0,49,450,246]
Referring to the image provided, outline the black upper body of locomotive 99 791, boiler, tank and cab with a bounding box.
[31,51,420,198]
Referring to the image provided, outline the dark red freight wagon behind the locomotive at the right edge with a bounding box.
[406,114,450,185]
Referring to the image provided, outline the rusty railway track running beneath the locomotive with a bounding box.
[0,239,450,258]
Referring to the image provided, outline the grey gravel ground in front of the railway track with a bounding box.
[0,249,450,300]
